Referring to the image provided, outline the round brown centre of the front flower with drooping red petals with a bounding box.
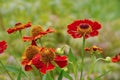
[41,48,55,63]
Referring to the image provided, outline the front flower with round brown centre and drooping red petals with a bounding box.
[32,48,67,74]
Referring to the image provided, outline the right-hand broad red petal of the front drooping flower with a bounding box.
[55,55,68,68]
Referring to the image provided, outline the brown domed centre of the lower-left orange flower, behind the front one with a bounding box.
[24,45,40,60]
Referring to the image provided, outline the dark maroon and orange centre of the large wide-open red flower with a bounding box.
[77,24,92,35]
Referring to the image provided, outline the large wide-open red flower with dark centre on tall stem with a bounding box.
[67,19,101,38]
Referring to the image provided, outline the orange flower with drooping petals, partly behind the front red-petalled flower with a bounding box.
[21,45,40,71]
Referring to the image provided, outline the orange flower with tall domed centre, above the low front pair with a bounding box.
[22,26,55,41]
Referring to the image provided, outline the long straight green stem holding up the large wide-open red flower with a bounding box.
[80,36,85,80]
